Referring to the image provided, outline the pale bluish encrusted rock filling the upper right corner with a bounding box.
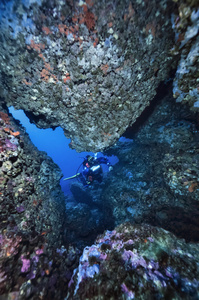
[172,0,199,111]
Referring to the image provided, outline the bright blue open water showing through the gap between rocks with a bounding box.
[9,106,118,194]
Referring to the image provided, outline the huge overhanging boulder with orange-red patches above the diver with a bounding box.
[0,0,176,152]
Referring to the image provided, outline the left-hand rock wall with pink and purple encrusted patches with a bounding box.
[0,110,79,300]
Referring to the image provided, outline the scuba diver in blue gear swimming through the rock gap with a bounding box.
[64,155,113,186]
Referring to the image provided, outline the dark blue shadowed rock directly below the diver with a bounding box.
[65,183,114,249]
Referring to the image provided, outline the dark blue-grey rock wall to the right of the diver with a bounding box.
[64,87,199,242]
